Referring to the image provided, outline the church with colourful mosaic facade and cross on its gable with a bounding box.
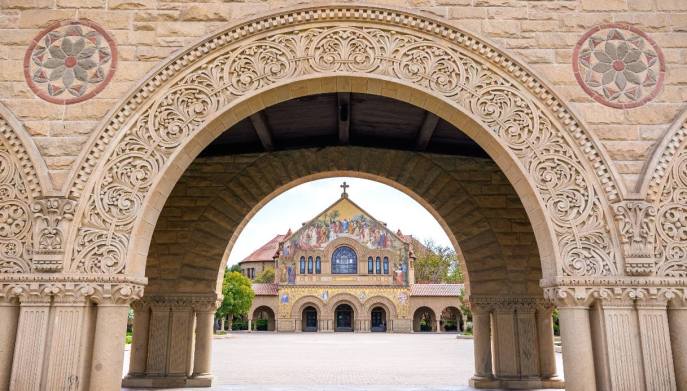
[239,182,464,332]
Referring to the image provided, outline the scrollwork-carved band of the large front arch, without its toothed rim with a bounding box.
[70,10,618,276]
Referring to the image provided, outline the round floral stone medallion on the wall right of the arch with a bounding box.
[572,23,665,109]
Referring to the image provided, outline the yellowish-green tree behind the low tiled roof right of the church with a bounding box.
[415,240,465,284]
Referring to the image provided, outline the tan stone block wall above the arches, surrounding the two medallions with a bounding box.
[0,0,687,191]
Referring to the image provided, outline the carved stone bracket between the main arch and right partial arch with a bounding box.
[613,201,656,276]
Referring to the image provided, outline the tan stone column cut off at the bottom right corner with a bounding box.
[668,292,687,391]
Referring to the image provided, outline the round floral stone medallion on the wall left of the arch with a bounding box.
[24,19,117,105]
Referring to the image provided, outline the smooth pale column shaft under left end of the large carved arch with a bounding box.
[89,304,129,391]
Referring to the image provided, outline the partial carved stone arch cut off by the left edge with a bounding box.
[0,104,51,273]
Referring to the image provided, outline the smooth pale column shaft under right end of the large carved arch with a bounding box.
[559,307,596,391]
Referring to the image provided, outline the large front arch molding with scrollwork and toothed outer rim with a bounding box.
[69,5,622,276]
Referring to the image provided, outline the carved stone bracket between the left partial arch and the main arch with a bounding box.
[31,198,76,272]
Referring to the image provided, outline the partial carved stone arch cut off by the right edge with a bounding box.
[640,105,687,278]
